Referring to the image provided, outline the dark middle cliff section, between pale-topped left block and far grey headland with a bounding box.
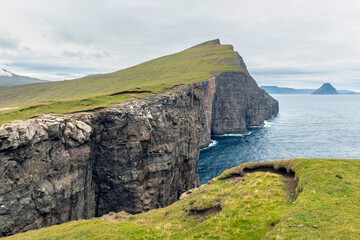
[92,85,203,216]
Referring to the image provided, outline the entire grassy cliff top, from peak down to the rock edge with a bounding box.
[0,40,246,124]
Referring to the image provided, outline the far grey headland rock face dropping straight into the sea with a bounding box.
[202,72,279,143]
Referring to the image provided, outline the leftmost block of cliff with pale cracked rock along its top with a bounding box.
[0,117,95,236]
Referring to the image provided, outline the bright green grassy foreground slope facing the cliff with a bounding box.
[5,159,360,240]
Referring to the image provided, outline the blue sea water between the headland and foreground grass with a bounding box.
[199,95,360,184]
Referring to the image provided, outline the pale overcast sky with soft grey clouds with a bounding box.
[0,0,360,91]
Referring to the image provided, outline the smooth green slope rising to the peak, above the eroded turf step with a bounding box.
[0,40,245,107]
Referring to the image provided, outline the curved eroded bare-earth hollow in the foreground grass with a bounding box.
[222,163,298,198]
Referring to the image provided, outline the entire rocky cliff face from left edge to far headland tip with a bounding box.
[0,72,278,236]
